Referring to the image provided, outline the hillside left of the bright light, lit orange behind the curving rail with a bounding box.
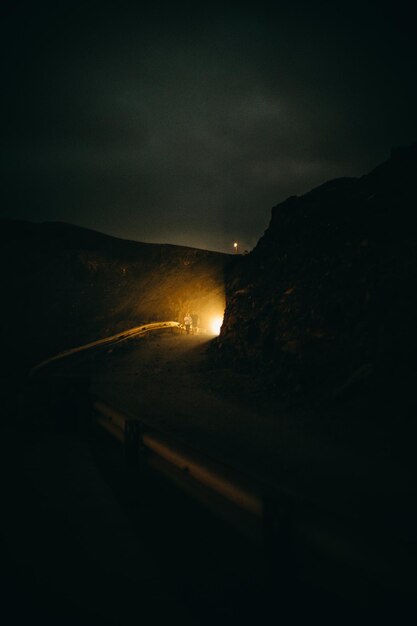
[0,220,228,372]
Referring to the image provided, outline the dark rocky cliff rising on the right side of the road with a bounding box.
[218,144,417,396]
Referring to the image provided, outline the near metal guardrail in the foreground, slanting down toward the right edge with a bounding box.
[93,400,412,596]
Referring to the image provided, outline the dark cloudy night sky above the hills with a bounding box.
[0,0,417,252]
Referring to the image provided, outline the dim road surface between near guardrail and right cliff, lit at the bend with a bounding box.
[88,333,400,509]
